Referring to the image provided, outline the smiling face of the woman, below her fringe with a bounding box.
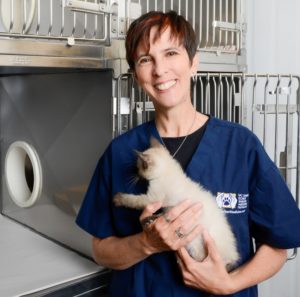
[135,27,198,109]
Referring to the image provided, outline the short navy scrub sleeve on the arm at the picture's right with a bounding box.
[249,157,300,249]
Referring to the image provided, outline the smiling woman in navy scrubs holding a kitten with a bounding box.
[77,12,300,297]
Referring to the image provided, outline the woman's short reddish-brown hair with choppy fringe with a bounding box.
[125,11,197,70]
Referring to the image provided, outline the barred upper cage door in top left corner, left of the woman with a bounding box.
[0,0,110,46]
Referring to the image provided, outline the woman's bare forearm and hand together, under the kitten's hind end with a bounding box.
[177,230,287,295]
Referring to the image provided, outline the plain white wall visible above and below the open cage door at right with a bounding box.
[245,0,300,297]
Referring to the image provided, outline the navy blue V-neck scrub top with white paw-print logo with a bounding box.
[77,117,300,297]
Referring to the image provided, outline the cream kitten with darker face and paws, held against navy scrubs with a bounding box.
[114,138,239,269]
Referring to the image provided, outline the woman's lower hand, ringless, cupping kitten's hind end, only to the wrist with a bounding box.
[177,230,237,295]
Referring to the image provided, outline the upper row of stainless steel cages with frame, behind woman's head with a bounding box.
[0,0,246,73]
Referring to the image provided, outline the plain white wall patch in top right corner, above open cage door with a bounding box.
[246,0,300,75]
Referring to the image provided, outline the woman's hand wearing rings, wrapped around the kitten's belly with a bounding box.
[140,200,201,255]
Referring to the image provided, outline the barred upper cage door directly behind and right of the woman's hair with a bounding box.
[141,0,245,53]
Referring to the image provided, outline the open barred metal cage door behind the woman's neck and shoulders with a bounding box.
[114,73,300,258]
